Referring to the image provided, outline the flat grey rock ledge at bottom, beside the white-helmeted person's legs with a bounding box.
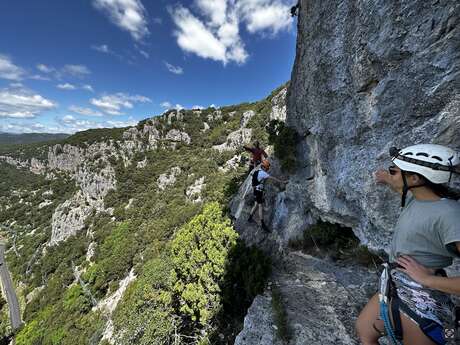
[235,252,378,345]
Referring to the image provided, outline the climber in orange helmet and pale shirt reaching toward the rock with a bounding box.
[248,159,287,232]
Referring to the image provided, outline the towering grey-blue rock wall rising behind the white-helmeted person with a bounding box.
[286,0,460,248]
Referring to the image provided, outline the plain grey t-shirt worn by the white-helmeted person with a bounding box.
[390,196,460,268]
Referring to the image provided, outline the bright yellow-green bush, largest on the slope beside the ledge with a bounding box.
[171,203,238,326]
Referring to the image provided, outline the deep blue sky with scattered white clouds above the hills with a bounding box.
[0,0,296,133]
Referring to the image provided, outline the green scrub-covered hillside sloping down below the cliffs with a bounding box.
[0,85,288,345]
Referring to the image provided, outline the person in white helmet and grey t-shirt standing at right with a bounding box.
[356,144,460,345]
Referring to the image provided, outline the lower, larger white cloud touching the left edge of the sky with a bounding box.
[0,88,57,118]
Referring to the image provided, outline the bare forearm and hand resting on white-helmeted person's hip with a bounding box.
[396,254,460,296]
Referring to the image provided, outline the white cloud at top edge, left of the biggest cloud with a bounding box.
[93,0,150,41]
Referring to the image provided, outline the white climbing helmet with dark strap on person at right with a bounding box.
[390,144,460,184]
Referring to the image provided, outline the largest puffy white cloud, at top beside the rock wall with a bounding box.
[170,0,293,65]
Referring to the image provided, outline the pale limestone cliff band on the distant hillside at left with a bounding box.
[0,119,191,245]
